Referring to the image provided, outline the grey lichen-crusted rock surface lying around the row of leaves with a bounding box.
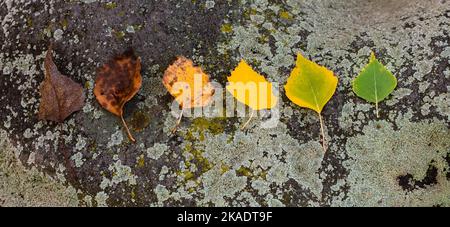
[0,0,450,206]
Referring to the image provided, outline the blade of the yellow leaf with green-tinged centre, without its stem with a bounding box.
[284,54,338,114]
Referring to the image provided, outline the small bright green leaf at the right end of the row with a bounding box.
[353,52,397,117]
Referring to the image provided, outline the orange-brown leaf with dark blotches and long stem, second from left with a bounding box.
[94,50,142,142]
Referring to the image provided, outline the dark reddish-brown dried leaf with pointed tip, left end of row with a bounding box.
[38,47,85,123]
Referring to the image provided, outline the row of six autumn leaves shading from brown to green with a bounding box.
[39,47,397,150]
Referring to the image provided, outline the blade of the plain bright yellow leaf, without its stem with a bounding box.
[227,60,278,110]
